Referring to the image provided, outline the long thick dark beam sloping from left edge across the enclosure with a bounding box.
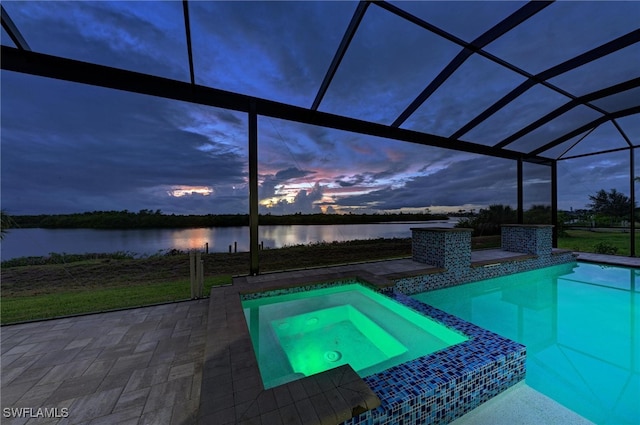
[0,46,553,165]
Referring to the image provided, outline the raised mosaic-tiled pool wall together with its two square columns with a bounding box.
[404,225,576,295]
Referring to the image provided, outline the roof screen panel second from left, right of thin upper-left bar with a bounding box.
[189,1,356,107]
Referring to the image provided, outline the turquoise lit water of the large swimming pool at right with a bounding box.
[414,263,640,424]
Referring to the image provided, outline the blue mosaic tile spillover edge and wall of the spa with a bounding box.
[345,290,526,425]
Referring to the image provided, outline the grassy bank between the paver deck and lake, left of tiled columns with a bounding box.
[0,239,411,324]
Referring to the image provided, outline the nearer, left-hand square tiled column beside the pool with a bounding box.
[411,227,473,273]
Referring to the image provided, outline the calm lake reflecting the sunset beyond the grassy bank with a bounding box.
[1,219,457,260]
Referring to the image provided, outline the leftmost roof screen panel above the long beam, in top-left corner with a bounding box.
[2,1,189,81]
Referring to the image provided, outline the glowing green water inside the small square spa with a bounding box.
[242,284,467,388]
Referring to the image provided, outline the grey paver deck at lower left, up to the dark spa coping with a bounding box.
[0,300,209,425]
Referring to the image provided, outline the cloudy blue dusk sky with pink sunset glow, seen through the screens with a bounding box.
[0,1,640,214]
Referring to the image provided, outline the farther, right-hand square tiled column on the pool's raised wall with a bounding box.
[502,224,553,255]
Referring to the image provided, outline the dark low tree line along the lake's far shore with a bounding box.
[3,209,448,229]
